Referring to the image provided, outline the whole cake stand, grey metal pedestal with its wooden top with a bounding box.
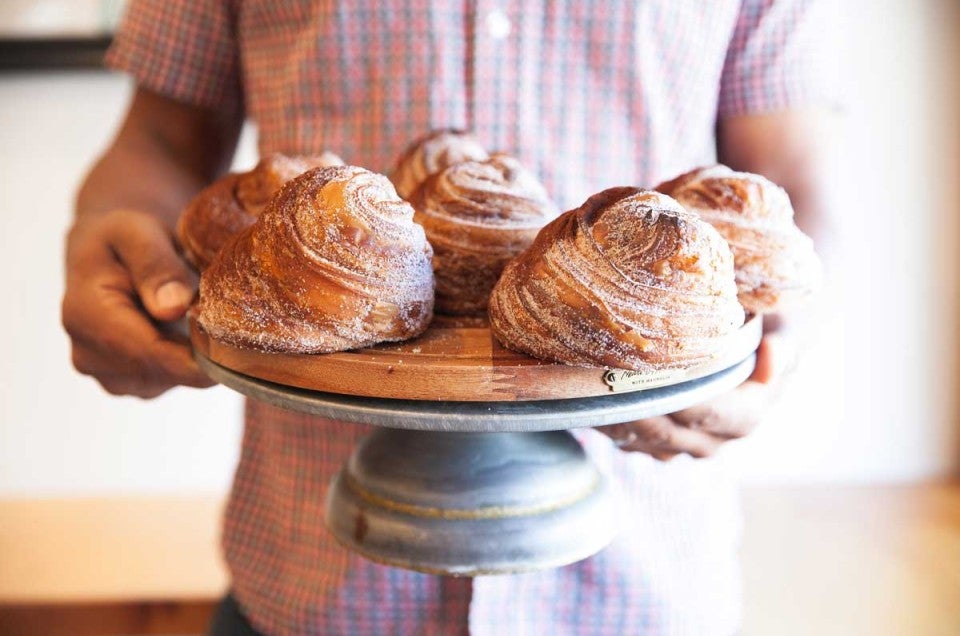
[191,318,761,576]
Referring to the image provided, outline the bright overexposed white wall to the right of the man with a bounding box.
[730,0,960,482]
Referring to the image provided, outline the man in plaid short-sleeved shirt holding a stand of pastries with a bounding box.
[63,0,823,635]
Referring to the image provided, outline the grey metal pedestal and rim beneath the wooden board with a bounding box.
[197,352,759,576]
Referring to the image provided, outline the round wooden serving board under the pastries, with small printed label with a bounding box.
[190,316,761,402]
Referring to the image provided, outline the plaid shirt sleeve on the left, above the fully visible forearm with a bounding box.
[106,0,242,108]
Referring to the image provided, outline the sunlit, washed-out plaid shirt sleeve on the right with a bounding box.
[717,0,836,119]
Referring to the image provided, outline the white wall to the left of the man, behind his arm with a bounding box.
[0,72,250,496]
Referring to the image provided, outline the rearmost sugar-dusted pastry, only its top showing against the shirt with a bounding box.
[390,128,490,199]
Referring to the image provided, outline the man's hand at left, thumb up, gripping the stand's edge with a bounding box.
[62,210,214,398]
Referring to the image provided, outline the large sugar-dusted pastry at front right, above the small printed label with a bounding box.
[490,188,744,371]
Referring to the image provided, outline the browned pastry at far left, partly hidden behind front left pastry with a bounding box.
[177,152,343,271]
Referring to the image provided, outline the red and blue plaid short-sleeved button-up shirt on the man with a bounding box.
[108,0,823,636]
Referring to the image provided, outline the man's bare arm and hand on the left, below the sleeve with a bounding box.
[62,89,243,398]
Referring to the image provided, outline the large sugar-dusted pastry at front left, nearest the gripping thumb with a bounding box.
[196,166,433,353]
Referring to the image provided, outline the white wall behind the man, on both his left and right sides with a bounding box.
[0,0,960,496]
